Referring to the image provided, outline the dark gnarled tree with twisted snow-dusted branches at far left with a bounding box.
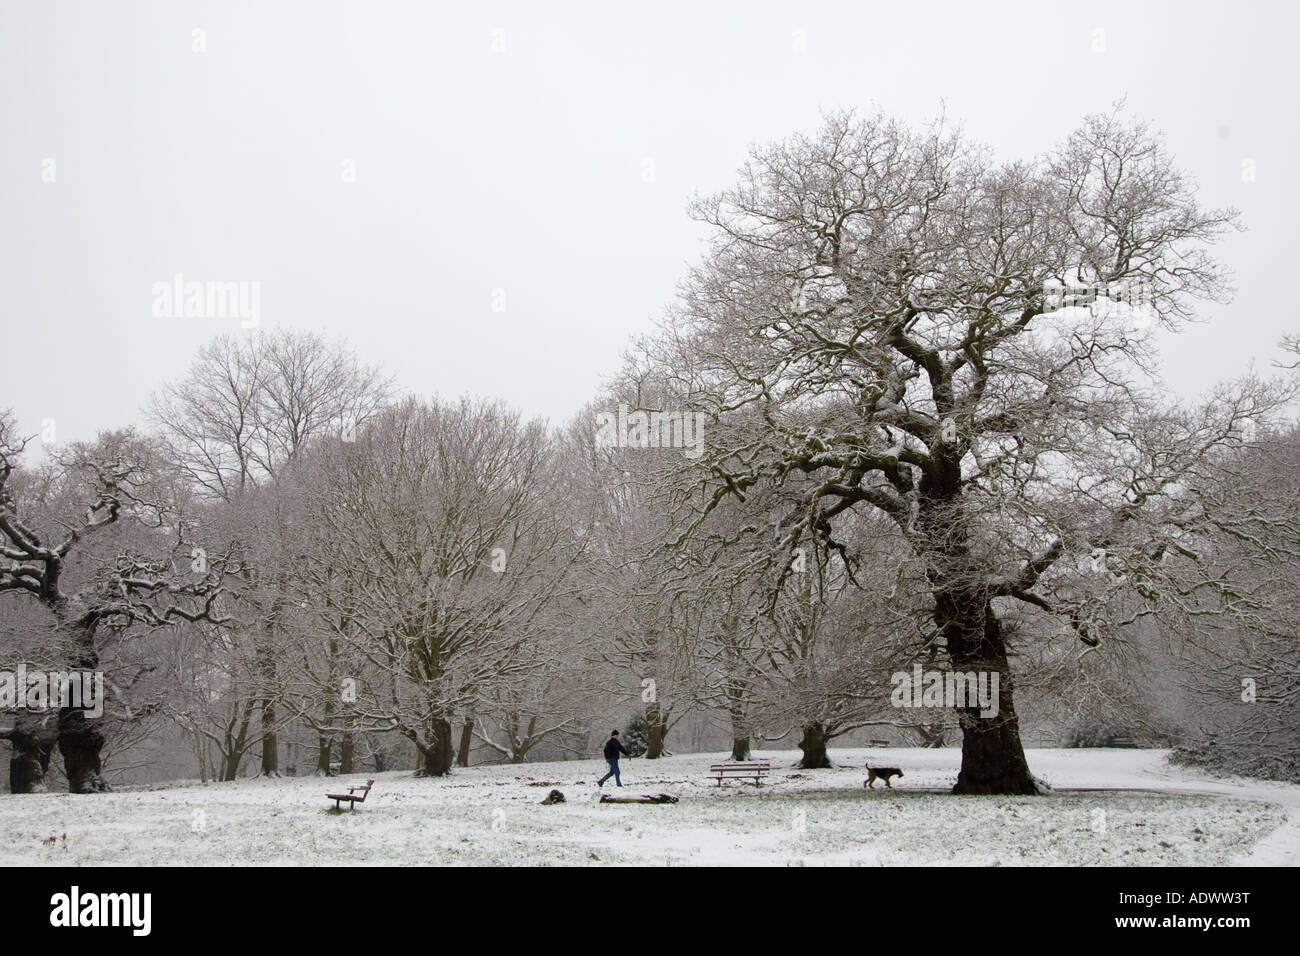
[0,415,229,793]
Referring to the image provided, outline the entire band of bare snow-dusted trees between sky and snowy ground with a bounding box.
[0,112,1300,793]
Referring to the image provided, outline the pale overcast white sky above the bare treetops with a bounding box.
[0,0,1300,441]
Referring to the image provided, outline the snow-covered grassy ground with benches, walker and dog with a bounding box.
[0,749,1300,866]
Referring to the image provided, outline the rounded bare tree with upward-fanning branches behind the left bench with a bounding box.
[300,401,582,775]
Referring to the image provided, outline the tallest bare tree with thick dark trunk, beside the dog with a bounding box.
[634,104,1283,793]
